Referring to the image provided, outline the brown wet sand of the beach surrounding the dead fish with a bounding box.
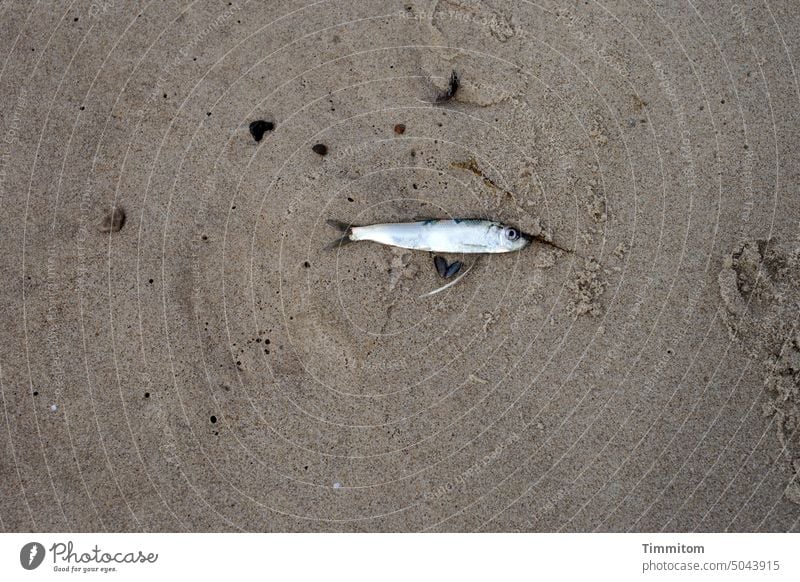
[0,0,800,532]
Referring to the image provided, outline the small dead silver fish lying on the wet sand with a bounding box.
[328,219,534,253]
